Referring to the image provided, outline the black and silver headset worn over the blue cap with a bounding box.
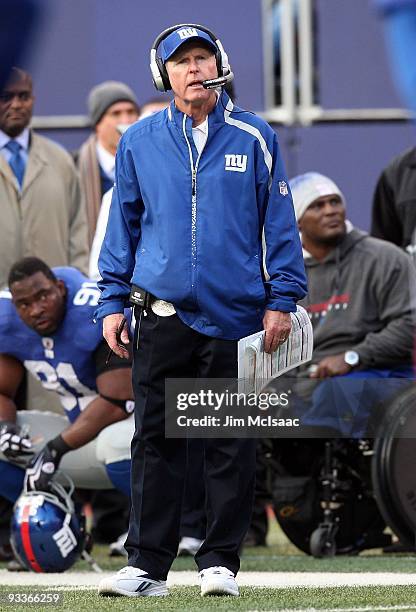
[150,23,234,91]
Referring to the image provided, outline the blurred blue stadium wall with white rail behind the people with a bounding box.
[24,0,414,229]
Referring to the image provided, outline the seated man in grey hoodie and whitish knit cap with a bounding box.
[290,172,415,437]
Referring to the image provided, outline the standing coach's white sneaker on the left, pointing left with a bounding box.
[98,565,169,597]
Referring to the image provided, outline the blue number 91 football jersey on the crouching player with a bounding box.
[0,268,103,422]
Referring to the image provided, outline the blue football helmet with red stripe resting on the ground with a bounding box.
[10,483,85,572]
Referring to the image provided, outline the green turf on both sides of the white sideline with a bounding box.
[0,522,416,612]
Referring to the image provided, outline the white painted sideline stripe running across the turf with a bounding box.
[0,569,416,592]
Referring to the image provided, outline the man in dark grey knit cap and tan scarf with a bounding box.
[75,81,139,246]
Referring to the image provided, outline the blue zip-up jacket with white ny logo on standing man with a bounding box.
[96,93,306,339]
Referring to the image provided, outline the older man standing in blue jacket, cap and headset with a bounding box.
[97,24,306,596]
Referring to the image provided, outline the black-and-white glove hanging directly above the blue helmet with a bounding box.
[23,436,71,491]
